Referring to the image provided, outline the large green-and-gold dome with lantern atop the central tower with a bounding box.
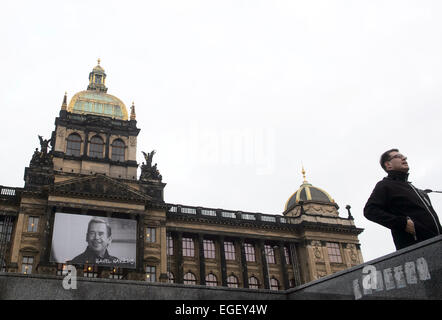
[67,60,128,120]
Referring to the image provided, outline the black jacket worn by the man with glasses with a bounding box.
[364,171,442,250]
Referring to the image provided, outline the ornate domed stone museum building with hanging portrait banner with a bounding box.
[0,62,363,290]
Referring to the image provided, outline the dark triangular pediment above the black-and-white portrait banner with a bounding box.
[50,174,152,202]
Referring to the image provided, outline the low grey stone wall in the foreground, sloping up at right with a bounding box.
[0,235,442,301]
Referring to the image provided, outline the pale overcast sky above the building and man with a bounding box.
[0,0,442,261]
